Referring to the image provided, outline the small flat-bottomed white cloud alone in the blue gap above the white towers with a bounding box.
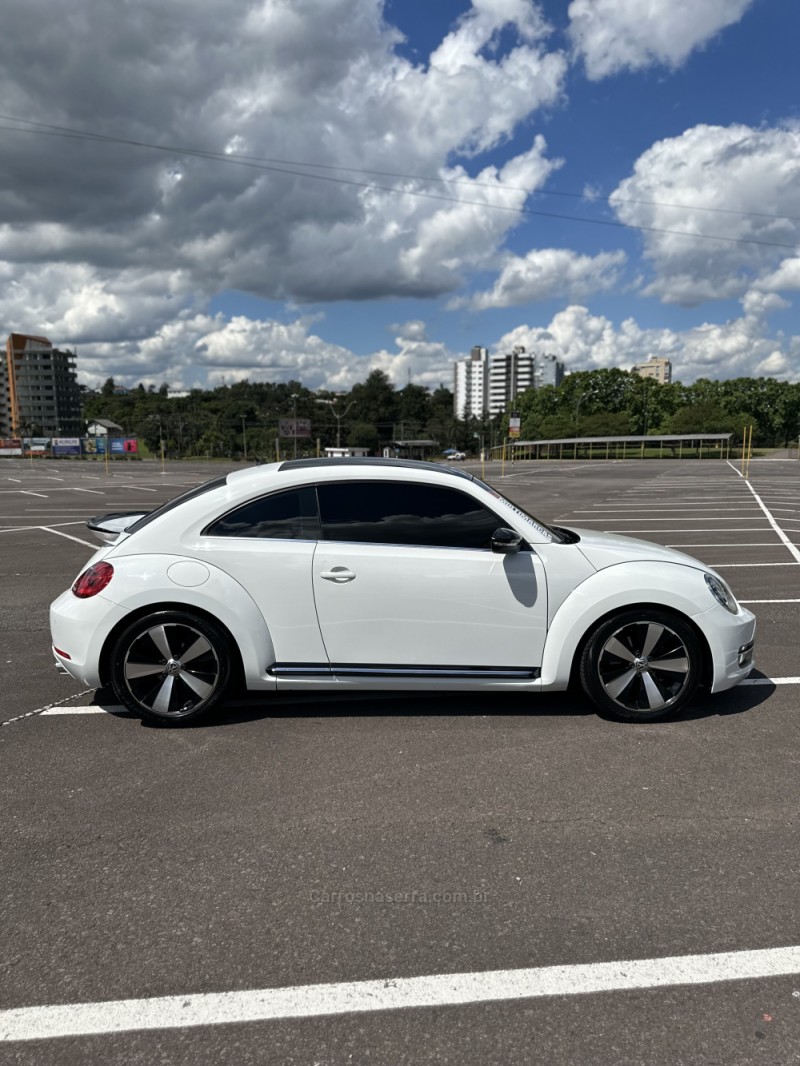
[451,248,625,310]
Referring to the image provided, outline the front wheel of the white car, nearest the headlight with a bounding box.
[580,608,703,722]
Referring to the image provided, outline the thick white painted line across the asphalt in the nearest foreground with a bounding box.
[0,947,800,1040]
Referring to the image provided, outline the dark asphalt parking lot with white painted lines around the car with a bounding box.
[0,459,800,1066]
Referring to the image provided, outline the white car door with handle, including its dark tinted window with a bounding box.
[313,481,547,676]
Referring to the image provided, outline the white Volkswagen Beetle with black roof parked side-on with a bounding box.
[50,458,755,725]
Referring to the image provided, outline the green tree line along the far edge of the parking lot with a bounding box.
[84,369,800,458]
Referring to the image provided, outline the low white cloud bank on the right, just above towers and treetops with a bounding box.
[495,305,800,384]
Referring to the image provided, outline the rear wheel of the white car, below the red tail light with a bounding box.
[110,611,233,725]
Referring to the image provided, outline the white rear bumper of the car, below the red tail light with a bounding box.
[50,591,128,689]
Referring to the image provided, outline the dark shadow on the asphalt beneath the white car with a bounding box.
[94,674,775,729]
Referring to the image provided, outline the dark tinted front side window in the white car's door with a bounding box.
[317,481,502,548]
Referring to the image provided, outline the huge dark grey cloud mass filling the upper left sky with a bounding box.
[0,0,566,319]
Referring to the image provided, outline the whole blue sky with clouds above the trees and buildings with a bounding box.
[0,0,800,391]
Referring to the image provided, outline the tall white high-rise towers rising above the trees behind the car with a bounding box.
[453,345,564,418]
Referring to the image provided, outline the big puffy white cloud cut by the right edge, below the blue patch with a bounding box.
[610,124,800,305]
